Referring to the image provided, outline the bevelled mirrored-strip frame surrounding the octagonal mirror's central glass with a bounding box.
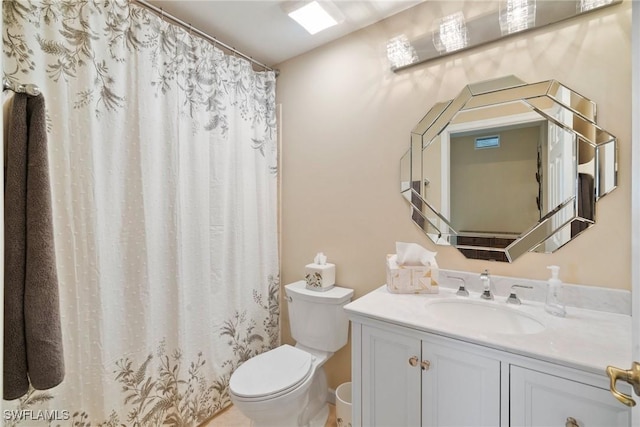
[401,76,618,262]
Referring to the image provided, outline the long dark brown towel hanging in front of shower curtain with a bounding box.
[3,93,64,400]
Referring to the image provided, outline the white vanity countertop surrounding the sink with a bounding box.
[345,285,631,374]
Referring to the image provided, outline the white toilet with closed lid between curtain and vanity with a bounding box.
[229,280,353,427]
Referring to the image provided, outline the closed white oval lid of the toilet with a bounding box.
[229,344,313,398]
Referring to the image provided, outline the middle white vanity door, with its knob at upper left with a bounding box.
[422,339,500,427]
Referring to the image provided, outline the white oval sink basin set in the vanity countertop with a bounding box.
[427,299,545,335]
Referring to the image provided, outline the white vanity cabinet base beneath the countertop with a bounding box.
[352,317,631,427]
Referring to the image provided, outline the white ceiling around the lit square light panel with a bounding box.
[148,0,424,66]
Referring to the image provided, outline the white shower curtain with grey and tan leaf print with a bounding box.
[2,0,279,426]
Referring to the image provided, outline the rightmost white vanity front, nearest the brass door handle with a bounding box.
[510,365,631,427]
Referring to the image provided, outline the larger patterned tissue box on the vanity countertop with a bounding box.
[387,254,439,294]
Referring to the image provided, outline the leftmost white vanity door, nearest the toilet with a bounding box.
[362,326,420,427]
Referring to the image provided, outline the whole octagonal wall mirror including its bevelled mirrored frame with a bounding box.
[401,76,617,262]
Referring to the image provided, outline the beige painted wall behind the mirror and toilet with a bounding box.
[277,1,631,387]
